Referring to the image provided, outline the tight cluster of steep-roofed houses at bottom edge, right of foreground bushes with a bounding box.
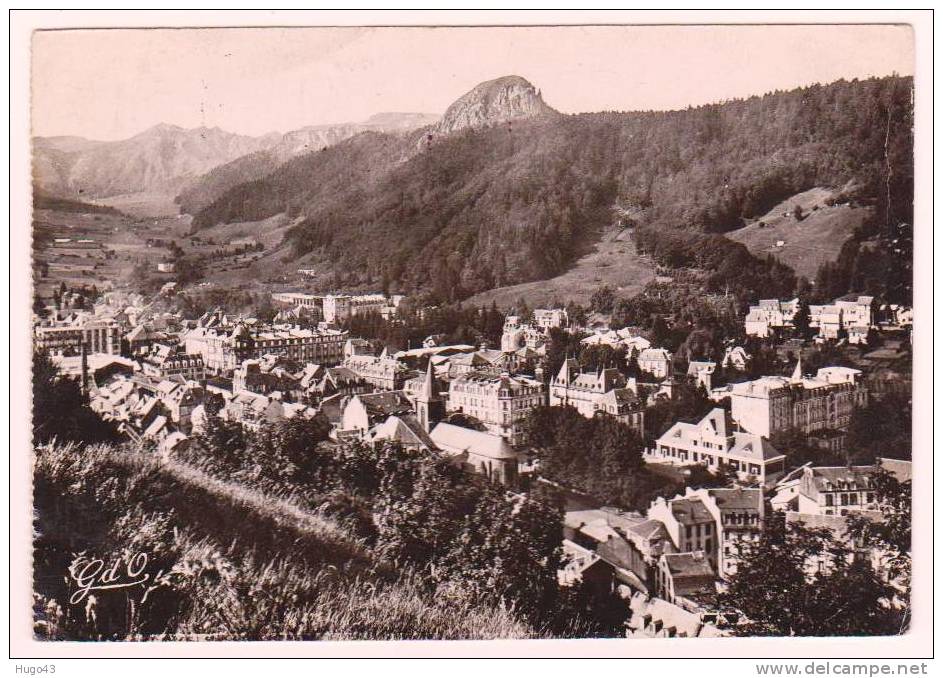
[561,487,765,637]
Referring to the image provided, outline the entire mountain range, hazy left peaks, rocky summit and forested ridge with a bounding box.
[34,76,913,301]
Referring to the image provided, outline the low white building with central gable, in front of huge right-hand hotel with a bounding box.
[646,407,786,484]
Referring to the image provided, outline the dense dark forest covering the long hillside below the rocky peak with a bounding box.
[188,77,913,300]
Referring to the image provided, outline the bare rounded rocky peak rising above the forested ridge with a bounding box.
[434,75,559,134]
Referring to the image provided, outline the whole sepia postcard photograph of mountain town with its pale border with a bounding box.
[10,11,933,666]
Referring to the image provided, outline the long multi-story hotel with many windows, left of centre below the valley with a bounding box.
[184,323,347,373]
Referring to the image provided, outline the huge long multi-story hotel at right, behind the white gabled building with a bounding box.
[730,361,868,438]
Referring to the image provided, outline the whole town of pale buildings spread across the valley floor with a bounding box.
[33,274,913,637]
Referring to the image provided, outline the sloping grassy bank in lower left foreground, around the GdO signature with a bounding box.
[34,445,541,640]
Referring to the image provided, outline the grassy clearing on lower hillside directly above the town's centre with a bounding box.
[466,228,655,308]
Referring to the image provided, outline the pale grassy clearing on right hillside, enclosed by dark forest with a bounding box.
[725,188,869,280]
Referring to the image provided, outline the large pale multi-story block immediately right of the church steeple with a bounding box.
[448,372,544,445]
